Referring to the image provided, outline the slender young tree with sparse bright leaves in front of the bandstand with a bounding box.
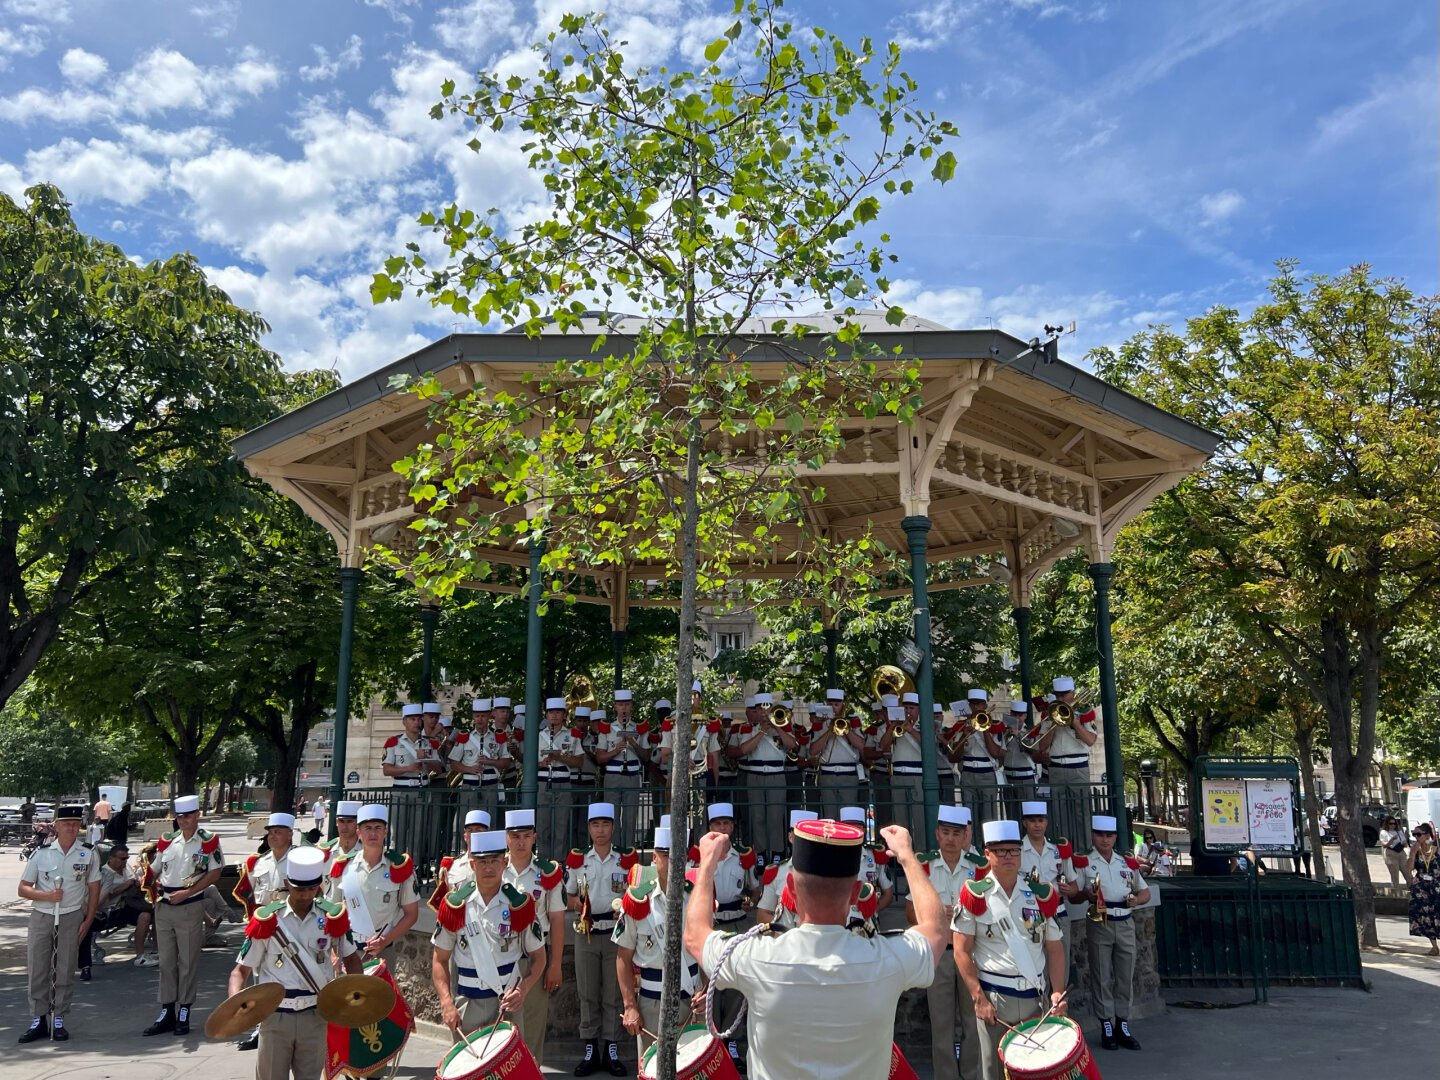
[372,0,955,1076]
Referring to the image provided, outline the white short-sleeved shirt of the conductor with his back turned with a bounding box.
[701,924,935,1080]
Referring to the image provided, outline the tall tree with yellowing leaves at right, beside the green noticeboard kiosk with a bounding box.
[1096,264,1440,945]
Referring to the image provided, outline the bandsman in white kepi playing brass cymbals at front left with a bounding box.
[229,848,360,1080]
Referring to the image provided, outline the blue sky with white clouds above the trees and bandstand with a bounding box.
[0,0,1440,377]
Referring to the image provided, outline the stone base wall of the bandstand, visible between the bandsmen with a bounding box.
[390,909,1165,1053]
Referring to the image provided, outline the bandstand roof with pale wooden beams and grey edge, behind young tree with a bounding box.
[233,317,1218,606]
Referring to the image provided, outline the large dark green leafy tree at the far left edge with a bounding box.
[0,184,279,703]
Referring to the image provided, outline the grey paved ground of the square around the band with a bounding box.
[0,824,1440,1080]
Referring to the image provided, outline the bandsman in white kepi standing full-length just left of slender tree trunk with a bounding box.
[564,802,639,1076]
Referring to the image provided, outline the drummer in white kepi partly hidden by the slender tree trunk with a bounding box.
[612,827,700,1051]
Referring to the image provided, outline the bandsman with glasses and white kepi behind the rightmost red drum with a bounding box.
[950,821,1066,1080]
